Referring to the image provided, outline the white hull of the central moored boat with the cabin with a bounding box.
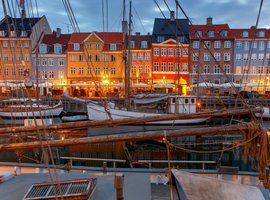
[87,103,209,124]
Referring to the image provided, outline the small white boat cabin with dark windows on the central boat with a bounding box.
[168,95,197,114]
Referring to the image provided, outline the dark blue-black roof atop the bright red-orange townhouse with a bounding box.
[153,18,189,43]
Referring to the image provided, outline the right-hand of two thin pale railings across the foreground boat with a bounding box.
[138,160,217,171]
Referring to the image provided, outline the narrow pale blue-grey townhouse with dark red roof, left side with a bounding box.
[37,28,71,86]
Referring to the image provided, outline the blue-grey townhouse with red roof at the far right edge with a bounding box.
[232,27,270,93]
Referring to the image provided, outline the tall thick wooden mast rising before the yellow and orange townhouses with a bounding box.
[122,0,131,109]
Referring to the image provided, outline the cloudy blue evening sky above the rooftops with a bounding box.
[0,0,270,34]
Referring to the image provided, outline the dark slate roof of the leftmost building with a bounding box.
[0,15,41,36]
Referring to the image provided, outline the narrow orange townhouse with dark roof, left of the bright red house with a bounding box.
[130,32,152,85]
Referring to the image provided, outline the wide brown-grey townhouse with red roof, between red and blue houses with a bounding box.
[189,17,234,93]
